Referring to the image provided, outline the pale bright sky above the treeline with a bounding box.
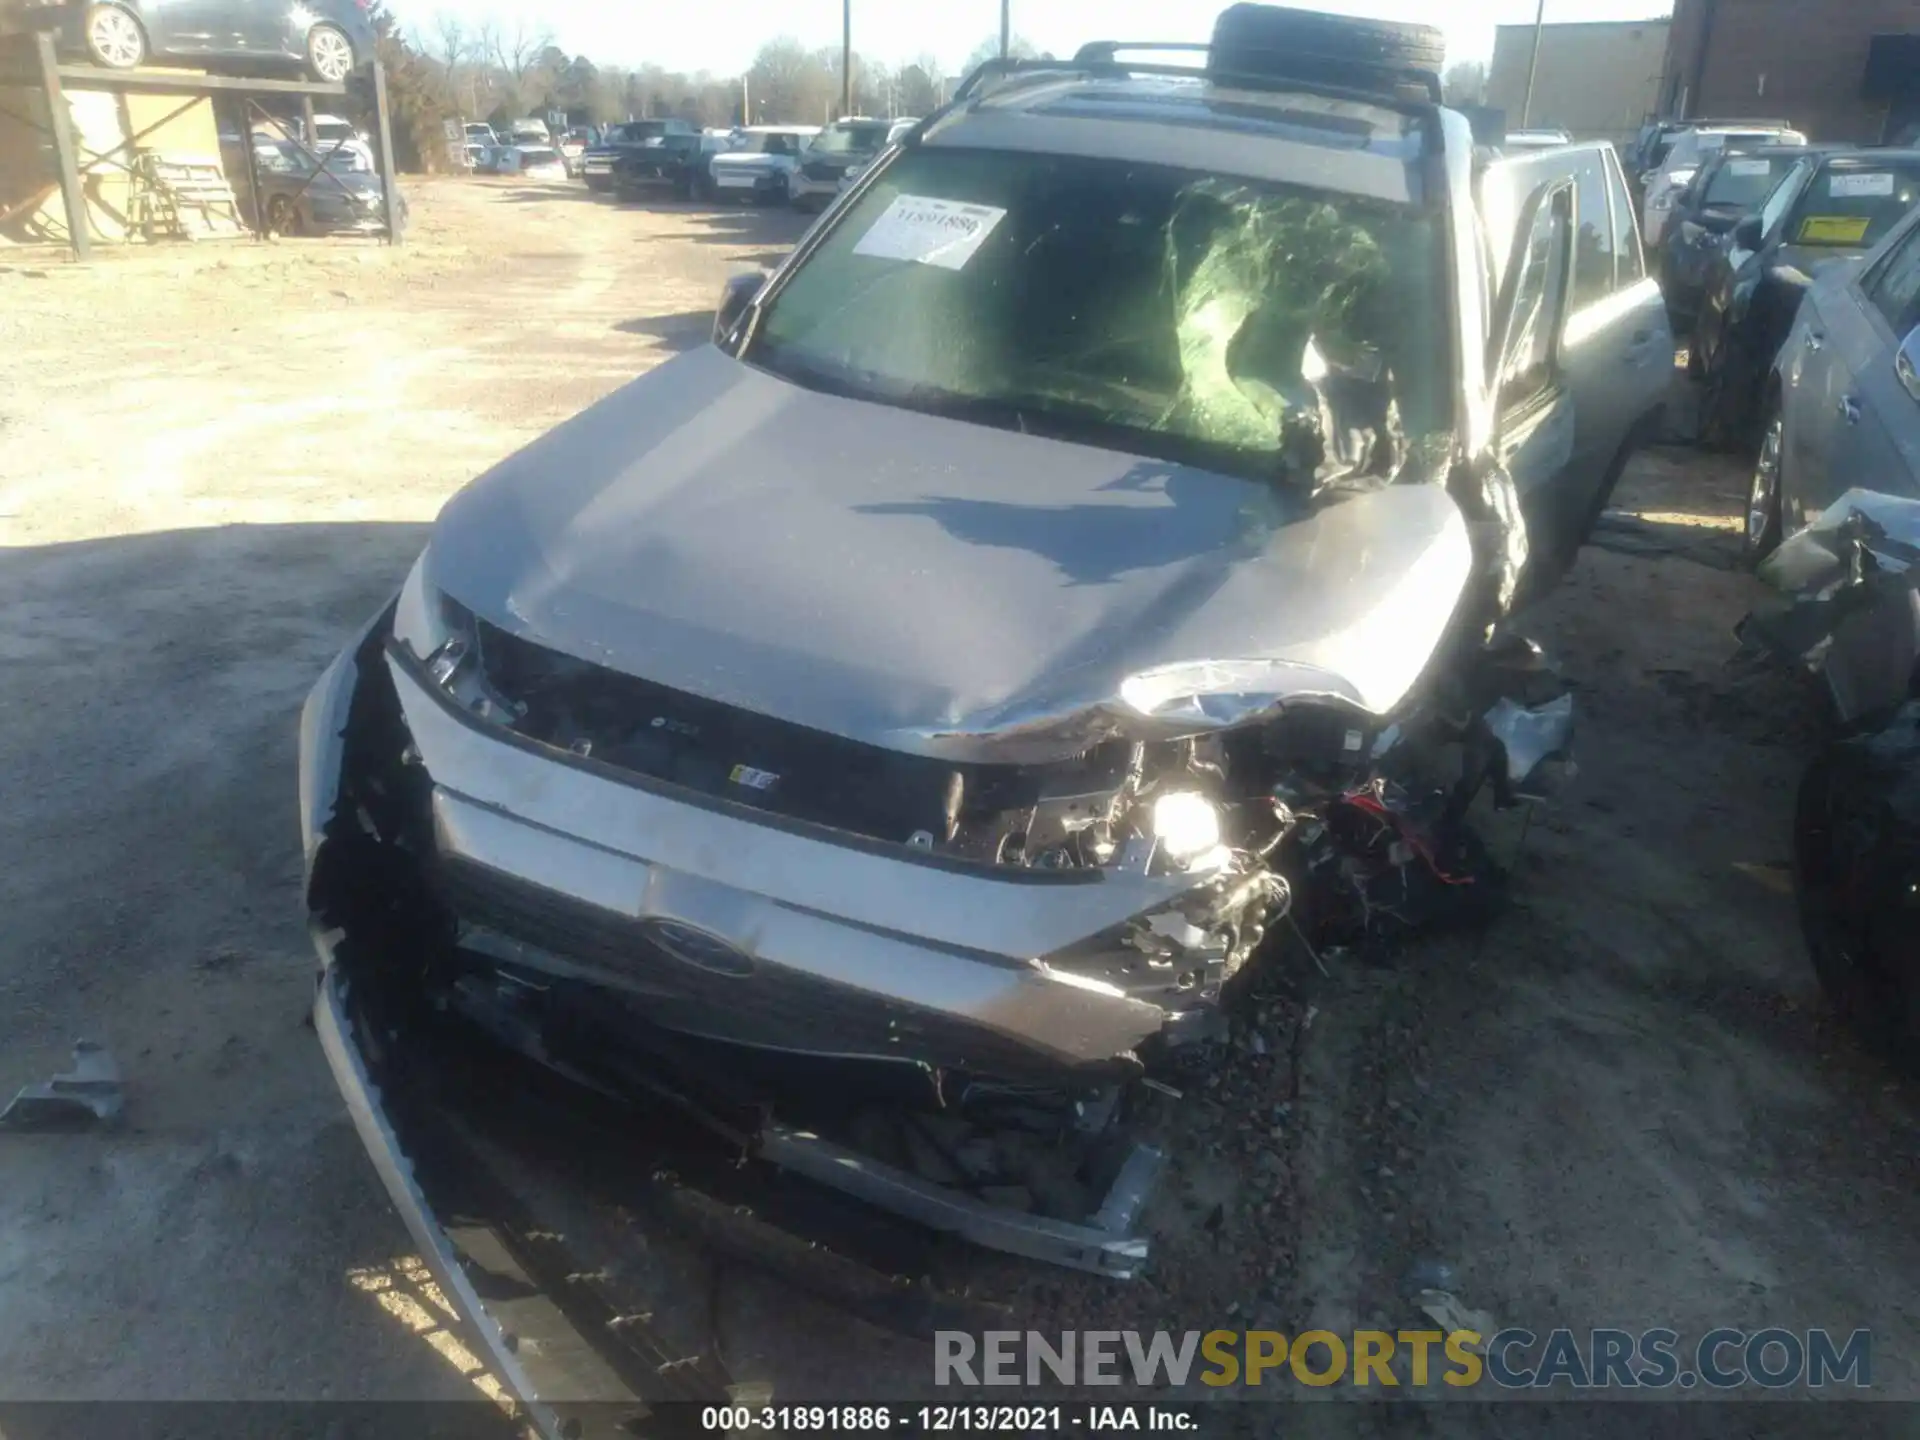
[388,0,1672,75]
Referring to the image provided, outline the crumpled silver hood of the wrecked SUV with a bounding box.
[432,346,1469,760]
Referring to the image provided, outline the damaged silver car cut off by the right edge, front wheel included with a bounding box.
[1740,211,1920,1071]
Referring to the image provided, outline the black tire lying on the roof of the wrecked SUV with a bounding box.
[1208,4,1446,90]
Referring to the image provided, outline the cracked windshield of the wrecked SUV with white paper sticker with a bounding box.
[747,150,1452,480]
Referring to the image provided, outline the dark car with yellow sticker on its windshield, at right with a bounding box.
[1690,150,1920,449]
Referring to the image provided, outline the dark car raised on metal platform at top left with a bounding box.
[54,0,372,83]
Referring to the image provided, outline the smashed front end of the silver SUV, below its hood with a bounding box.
[301,572,1571,1367]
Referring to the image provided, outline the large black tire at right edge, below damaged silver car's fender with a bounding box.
[1793,721,1920,1073]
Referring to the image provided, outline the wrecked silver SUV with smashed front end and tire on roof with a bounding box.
[301,6,1665,1420]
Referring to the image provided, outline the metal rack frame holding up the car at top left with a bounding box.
[0,31,403,261]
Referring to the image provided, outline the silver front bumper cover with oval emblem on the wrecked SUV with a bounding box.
[301,595,1259,1081]
